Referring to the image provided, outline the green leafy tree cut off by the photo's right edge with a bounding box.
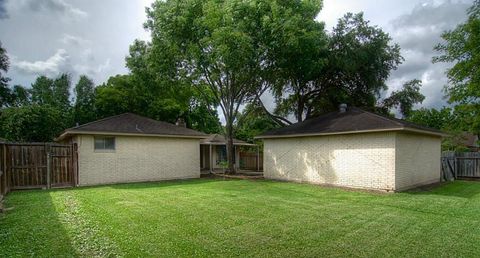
[433,0,480,136]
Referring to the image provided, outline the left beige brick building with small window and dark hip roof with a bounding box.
[57,113,208,185]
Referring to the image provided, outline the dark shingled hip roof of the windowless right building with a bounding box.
[255,107,446,138]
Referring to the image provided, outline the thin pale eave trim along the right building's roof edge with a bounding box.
[254,127,448,139]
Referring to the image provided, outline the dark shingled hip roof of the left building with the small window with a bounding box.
[56,113,208,141]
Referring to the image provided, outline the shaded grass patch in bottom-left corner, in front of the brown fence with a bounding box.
[0,190,79,257]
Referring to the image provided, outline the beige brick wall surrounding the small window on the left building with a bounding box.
[75,135,200,185]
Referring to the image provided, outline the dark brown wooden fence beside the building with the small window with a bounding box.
[6,143,76,190]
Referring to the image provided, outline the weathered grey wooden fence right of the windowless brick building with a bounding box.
[442,152,480,180]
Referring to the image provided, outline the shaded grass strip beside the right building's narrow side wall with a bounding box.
[405,180,480,199]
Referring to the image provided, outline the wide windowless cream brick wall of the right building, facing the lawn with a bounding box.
[264,132,395,190]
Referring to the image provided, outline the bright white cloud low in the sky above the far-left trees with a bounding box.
[12,49,70,76]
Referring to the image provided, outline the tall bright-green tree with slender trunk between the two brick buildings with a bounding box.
[145,0,320,172]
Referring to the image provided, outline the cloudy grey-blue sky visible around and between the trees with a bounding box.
[0,0,473,115]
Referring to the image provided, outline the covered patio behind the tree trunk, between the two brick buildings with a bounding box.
[200,134,263,173]
